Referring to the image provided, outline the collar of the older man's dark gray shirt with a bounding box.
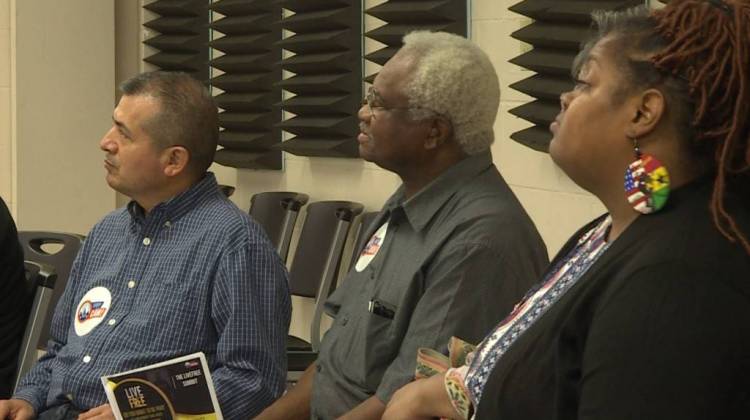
[385,150,492,232]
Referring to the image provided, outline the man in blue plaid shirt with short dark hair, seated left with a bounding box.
[0,72,291,420]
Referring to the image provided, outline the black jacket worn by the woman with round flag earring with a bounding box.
[477,179,750,420]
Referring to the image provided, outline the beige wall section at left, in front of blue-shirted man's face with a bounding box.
[12,0,115,233]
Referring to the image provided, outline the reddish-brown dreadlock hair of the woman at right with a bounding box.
[573,0,750,254]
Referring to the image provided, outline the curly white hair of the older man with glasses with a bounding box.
[399,31,500,155]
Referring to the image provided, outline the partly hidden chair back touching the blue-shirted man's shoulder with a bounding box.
[249,191,308,263]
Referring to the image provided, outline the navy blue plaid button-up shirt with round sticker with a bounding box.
[14,173,291,419]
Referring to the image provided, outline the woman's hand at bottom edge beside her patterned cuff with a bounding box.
[383,375,460,420]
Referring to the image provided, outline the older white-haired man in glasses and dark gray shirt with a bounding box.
[260,31,547,419]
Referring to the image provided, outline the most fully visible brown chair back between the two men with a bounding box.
[289,201,364,352]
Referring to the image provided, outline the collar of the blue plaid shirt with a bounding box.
[128,172,221,225]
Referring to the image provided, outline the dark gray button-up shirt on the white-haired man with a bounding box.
[312,152,548,419]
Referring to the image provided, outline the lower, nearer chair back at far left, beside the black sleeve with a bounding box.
[13,261,57,389]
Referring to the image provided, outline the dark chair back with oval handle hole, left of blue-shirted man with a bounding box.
[18,231,83,348]
